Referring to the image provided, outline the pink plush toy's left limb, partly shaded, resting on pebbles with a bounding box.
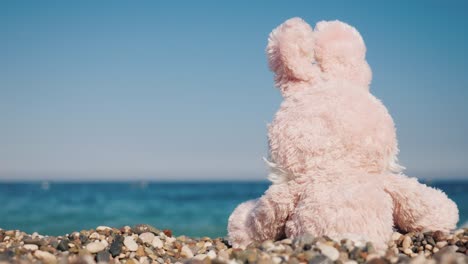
[228,183,294,248]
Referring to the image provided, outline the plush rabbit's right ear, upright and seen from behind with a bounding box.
[314,21,372,88]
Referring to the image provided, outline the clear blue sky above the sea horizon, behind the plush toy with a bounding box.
[0,1,468,180]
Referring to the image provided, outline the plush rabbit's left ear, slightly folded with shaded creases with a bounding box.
[267,17,320,95]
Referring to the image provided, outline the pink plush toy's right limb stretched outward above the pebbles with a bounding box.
[383,174,458,232]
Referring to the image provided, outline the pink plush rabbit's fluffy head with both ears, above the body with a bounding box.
[267,18,402,178]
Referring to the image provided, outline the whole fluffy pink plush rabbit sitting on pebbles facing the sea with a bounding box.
[228,18,458,249]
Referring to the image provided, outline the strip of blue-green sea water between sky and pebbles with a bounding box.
[0,181,468,237]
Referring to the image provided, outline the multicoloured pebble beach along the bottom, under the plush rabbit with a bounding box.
[0,224,468,264]
